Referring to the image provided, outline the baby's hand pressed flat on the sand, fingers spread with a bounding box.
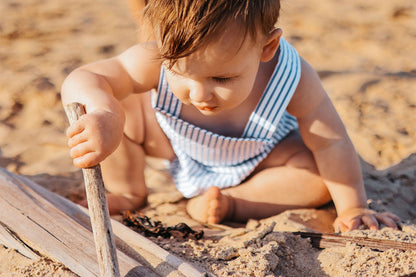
[333,208,400,232]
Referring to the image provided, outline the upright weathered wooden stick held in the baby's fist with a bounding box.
[66,103,120,277]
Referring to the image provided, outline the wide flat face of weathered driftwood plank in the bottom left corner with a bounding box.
[0,168,157,277]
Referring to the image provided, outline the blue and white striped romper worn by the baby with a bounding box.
[152,38,300,198]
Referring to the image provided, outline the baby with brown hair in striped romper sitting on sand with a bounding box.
[62,0,399,232]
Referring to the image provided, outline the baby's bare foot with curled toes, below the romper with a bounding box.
[186,184,234,224]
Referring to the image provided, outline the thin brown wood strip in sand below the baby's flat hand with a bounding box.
[293,232,416,251]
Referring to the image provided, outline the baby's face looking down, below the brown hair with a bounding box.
[165,28,261,115]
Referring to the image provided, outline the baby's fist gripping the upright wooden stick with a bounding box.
[66,111,124,168]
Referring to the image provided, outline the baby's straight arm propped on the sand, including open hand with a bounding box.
[288,60,399,232]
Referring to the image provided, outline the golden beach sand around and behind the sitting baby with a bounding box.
[0,0,416,276]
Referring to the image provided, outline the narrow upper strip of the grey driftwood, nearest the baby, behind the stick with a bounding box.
[0,168,210,277]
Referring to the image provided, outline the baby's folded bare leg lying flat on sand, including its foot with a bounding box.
[188,132,331,223]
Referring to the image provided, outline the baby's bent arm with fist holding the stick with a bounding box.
[61,42,160,167]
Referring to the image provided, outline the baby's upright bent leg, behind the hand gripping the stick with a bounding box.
[101,92,173,214]
